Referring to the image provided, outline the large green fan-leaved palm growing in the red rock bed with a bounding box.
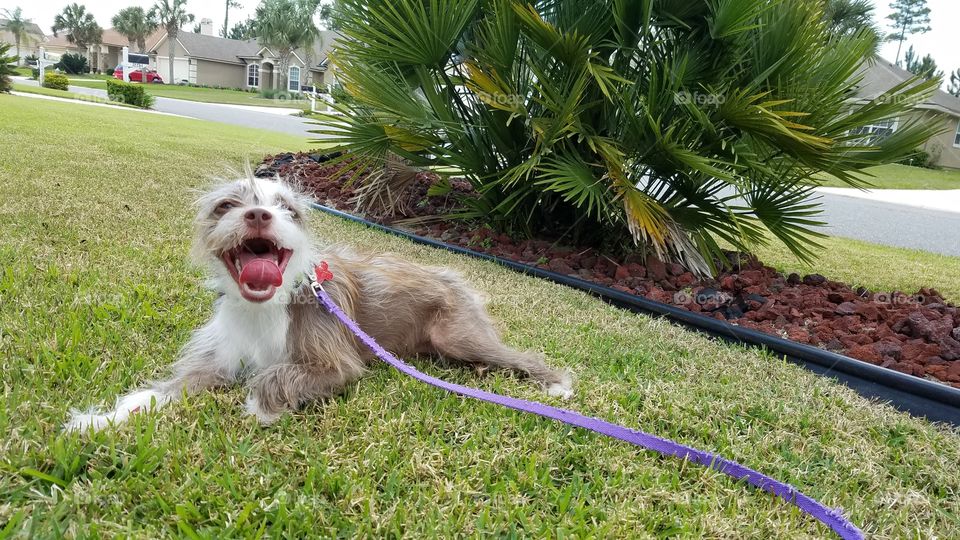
[319,0,935,273]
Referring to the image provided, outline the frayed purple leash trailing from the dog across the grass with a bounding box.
[309,276,864,540]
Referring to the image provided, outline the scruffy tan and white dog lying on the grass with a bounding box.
[65,174,572,431]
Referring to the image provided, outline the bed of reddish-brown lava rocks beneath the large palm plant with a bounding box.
[257,154,960,388]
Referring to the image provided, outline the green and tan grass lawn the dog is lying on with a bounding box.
[0,96,960,538]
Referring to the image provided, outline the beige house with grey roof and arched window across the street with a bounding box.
[147,19,337,92]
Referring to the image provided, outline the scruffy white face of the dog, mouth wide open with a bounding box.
[193,178,310,303]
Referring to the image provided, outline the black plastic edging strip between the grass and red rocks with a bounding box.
[311,203,960,427]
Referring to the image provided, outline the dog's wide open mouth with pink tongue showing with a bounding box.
[220,238,293,302]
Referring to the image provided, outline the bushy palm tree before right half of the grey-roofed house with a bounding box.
[256,0,320,90]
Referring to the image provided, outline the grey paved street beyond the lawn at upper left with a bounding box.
[17,79,321,139]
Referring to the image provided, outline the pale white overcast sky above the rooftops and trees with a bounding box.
[0,0,960,80]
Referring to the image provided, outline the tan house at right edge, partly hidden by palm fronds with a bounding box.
[856,57,960,169]
